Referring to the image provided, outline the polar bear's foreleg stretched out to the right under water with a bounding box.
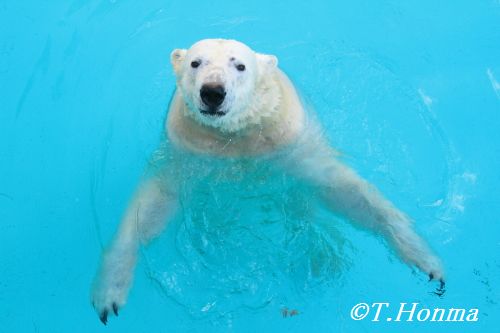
[284,133,444,285]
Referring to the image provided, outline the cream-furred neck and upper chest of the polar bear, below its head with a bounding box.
[166,69,305,156]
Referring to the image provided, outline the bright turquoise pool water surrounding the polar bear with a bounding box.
[0,0,500,332]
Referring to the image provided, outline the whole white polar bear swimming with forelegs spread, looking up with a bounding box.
[91,39,444,324]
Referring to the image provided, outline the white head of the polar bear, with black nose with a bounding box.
[171,39,279,132]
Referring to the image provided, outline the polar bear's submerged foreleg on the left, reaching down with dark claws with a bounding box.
[91,178,176,324]
